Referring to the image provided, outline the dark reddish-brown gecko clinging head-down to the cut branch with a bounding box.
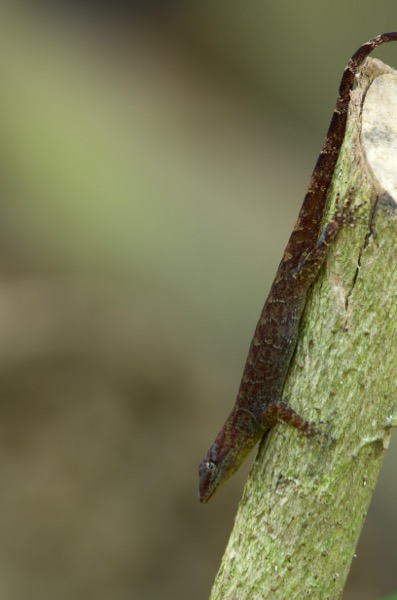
[198,32,397,503]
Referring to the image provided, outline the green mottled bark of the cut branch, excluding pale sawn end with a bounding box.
[211,60,397,600]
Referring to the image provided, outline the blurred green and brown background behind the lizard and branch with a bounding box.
[0,0,397,600]
